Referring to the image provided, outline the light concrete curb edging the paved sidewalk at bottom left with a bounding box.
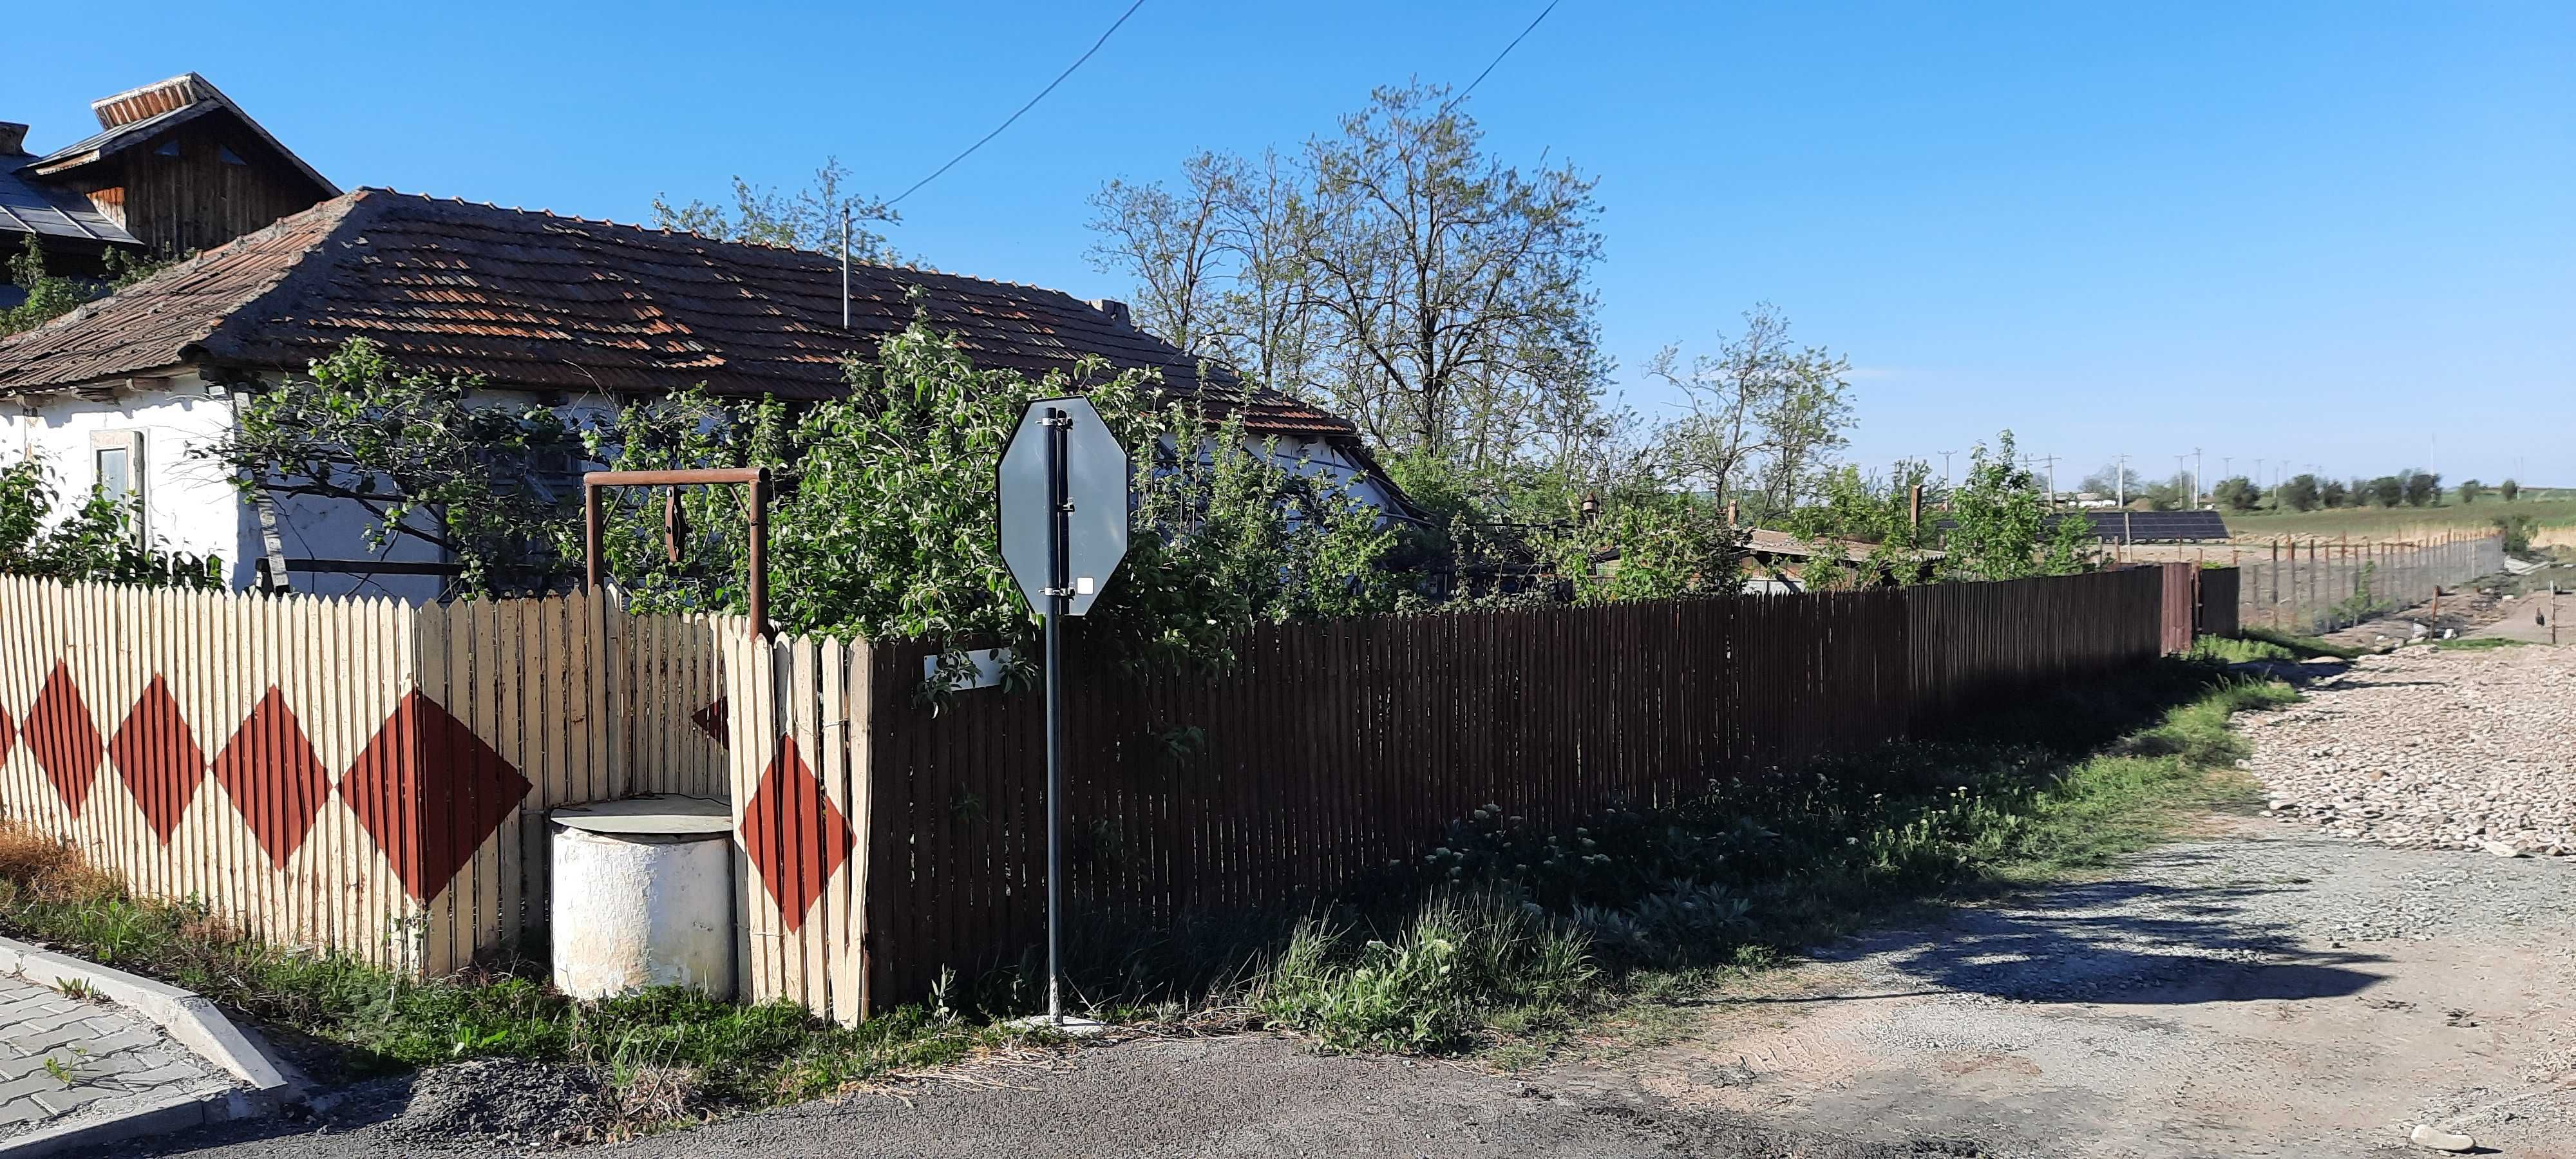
[0,938,299,1159]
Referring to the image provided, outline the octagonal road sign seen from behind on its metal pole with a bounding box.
[994,399,1128,1030]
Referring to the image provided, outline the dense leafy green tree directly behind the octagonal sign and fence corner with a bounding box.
[592,325,1394,659]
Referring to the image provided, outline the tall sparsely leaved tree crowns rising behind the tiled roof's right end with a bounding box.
[1092,85,1605,489]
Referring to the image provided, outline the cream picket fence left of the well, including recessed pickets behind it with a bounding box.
[0,577,747,974]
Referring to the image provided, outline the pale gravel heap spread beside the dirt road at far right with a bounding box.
[2239,646,2576,858]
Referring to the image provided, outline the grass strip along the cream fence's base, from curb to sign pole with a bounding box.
[0,824,1010,1131]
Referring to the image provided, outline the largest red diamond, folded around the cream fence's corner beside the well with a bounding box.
[340,693,536,901]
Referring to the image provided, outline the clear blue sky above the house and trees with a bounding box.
[0,0,2576,484]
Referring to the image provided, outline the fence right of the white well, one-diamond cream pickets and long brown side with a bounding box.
[726,569,2166,1017]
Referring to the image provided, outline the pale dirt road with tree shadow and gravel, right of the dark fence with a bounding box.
[1633,649,2576,1156]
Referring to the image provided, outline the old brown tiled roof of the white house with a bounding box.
[0,188,1355,440]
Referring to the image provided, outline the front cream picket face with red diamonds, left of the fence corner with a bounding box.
[0,577,425,968]
